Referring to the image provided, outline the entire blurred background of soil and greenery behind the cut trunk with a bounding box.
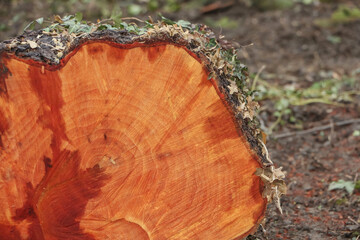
[0,0,360,240]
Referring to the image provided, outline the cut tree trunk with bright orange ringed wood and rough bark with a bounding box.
[0,21,281,239]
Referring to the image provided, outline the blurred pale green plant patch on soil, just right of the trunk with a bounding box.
[253,75,360,135]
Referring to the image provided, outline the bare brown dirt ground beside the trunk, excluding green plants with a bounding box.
[0,0,360,240]
